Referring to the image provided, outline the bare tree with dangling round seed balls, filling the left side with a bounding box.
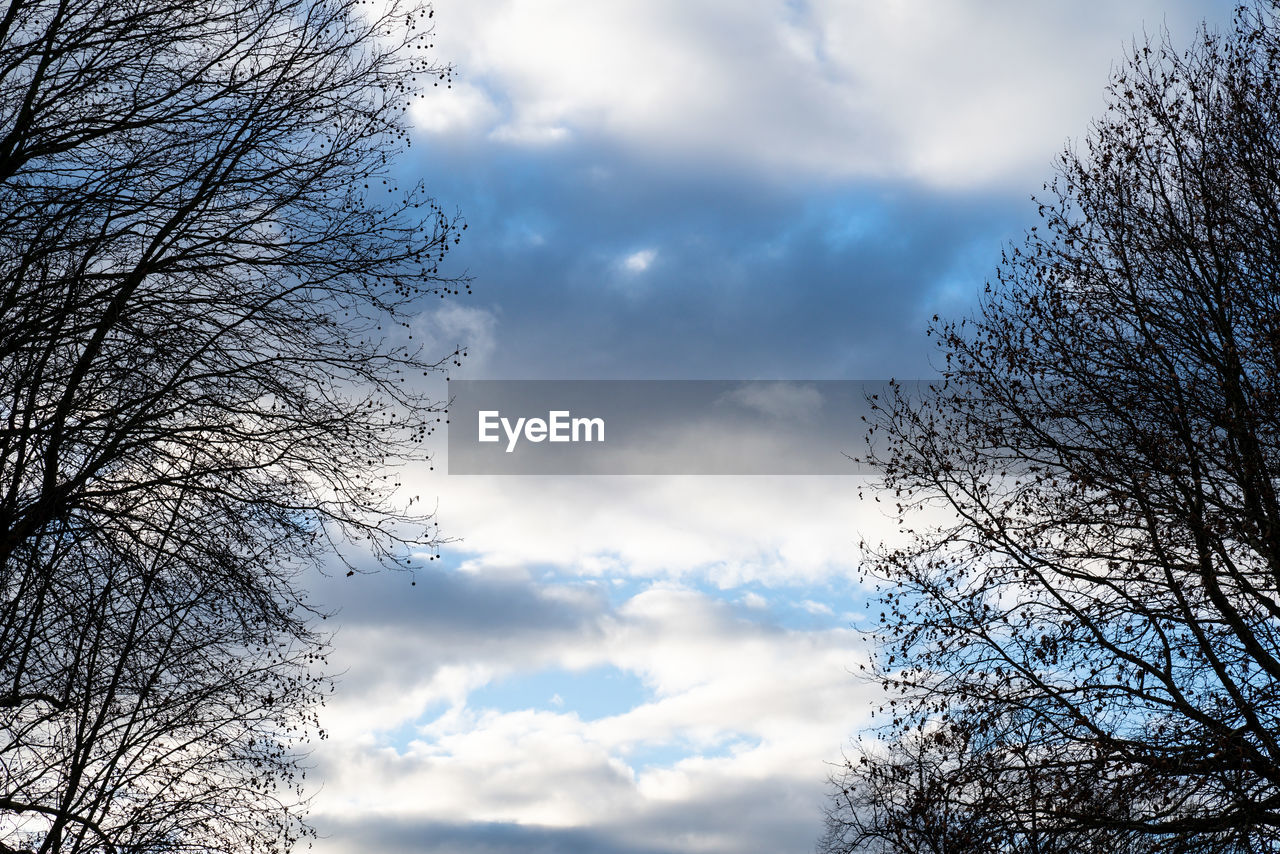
[0,0,466,854]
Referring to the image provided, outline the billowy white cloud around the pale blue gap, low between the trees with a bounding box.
[304,585,870,854]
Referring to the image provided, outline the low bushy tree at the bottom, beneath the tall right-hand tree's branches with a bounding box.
[818,709,1203,854]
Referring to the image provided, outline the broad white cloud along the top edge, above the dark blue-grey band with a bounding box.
[419,0,1229,187]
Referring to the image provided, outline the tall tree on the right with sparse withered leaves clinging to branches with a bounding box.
[839,4,1280,851]
